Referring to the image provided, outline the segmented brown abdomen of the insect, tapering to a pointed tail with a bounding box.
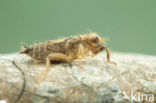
[21,40,66,61]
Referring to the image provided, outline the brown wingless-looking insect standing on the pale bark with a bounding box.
[20,33,116,82]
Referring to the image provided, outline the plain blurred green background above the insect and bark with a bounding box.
[0,0,156,55]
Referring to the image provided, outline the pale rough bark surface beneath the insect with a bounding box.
[0,53,156,103]
